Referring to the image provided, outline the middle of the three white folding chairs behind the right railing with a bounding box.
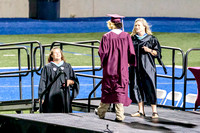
[163,91,182,107]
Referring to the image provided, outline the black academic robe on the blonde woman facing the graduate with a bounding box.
[129,35,166,104]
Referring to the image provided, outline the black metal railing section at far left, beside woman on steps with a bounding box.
[0,41,43,112]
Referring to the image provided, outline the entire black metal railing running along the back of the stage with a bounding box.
[0,40,200,112]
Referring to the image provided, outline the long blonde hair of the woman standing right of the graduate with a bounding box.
[131,18,152,36]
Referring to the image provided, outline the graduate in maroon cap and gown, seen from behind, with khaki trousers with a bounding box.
[95,14,136,121]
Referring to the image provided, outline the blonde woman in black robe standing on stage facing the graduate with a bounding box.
[129,18,165,118]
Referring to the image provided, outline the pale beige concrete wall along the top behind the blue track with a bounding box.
[0,0,200,18]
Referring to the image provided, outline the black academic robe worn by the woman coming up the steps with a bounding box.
[38,62,79,113]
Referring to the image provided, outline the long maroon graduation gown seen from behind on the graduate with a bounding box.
[99,31,136,106]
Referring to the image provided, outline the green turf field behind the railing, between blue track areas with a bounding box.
[0,32,200,67]
